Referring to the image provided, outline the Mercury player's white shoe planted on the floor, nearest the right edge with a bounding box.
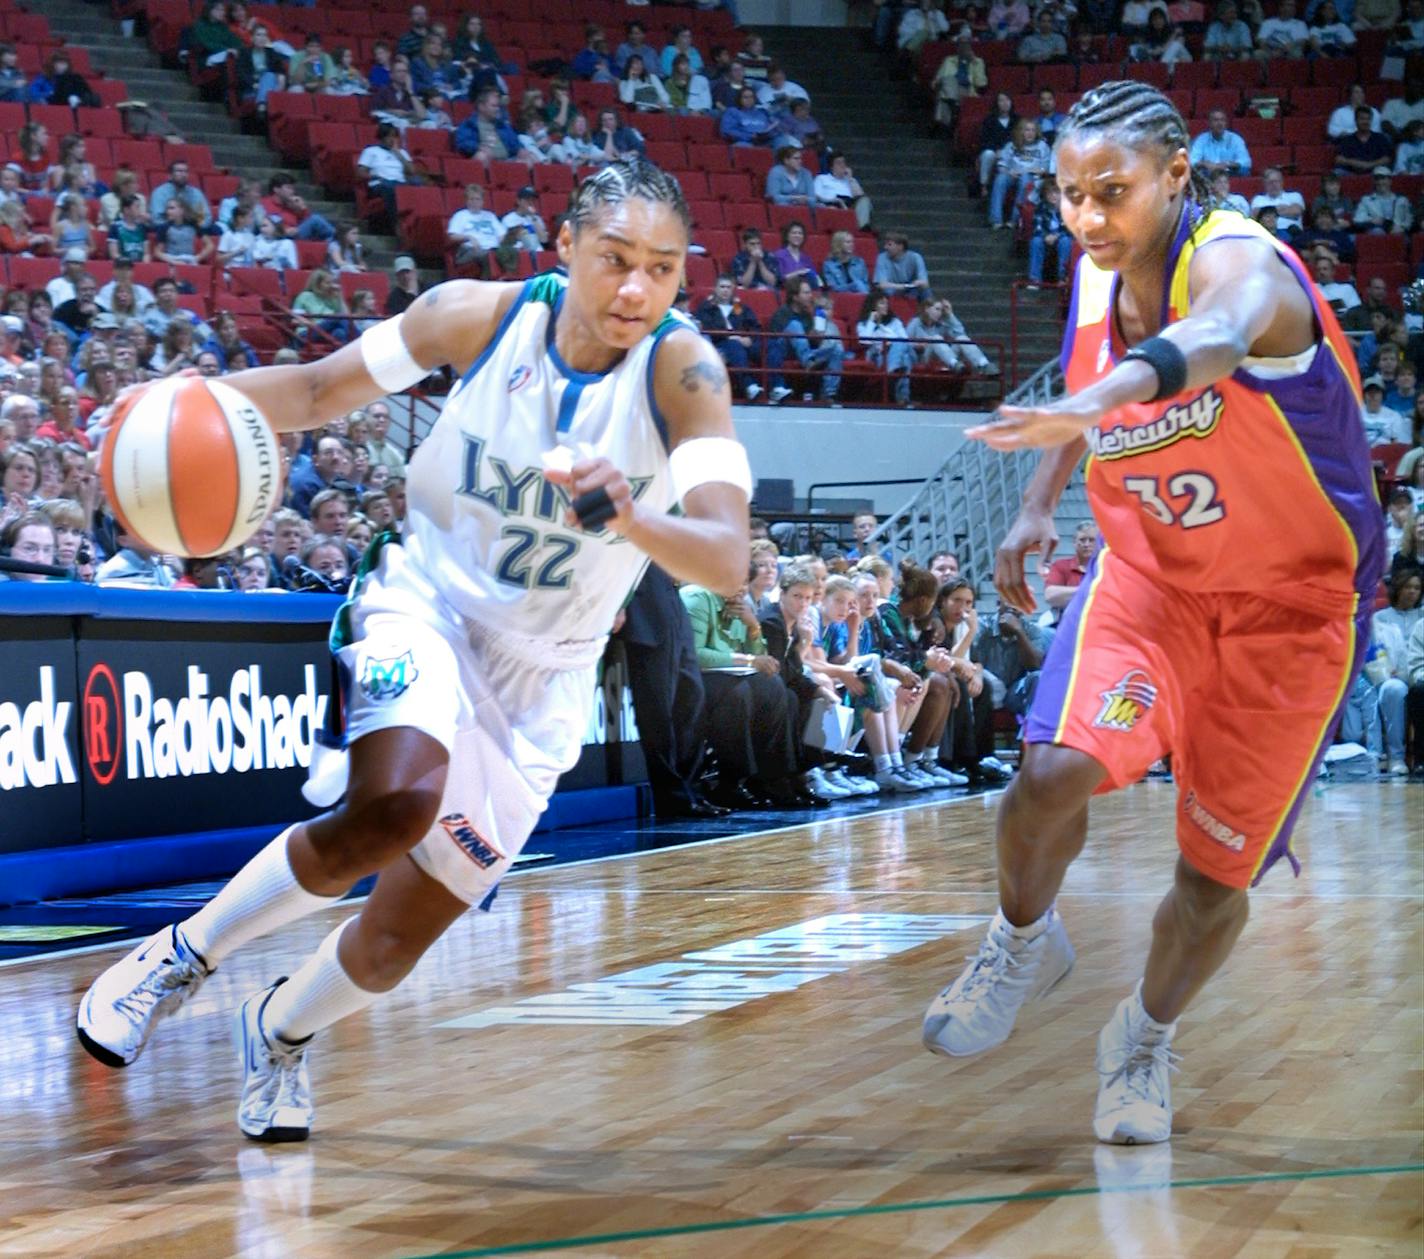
[1092,984,1182,1145]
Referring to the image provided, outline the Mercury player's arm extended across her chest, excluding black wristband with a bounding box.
[968,239,1316,450]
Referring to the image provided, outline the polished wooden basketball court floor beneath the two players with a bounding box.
[0,783,1424,1259]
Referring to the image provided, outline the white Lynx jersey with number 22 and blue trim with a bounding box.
[404,273,696,655]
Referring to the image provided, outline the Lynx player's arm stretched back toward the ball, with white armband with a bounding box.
[224,279,518,433]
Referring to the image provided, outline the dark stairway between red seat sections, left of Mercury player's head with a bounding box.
[762,27,1058,376]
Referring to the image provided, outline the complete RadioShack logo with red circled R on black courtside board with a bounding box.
[82,662,326,786]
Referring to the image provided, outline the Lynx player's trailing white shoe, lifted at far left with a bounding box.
[75,926,212,1067]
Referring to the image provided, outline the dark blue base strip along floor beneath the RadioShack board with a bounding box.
[0,786,638,904]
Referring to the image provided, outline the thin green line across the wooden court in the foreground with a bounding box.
[395,1162,1424,1259]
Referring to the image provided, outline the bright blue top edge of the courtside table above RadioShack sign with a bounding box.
[0,581,342,625]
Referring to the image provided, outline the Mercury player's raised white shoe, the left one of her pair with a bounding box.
[920,907,1074,1058]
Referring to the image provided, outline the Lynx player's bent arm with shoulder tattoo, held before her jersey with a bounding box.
[545,329,750,592]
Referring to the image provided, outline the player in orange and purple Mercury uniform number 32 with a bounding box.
[924,83,1384,1144]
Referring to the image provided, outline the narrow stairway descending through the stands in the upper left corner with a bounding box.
[43,0,412,274]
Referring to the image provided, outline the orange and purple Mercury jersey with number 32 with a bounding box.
[1062,205,1384,617]
